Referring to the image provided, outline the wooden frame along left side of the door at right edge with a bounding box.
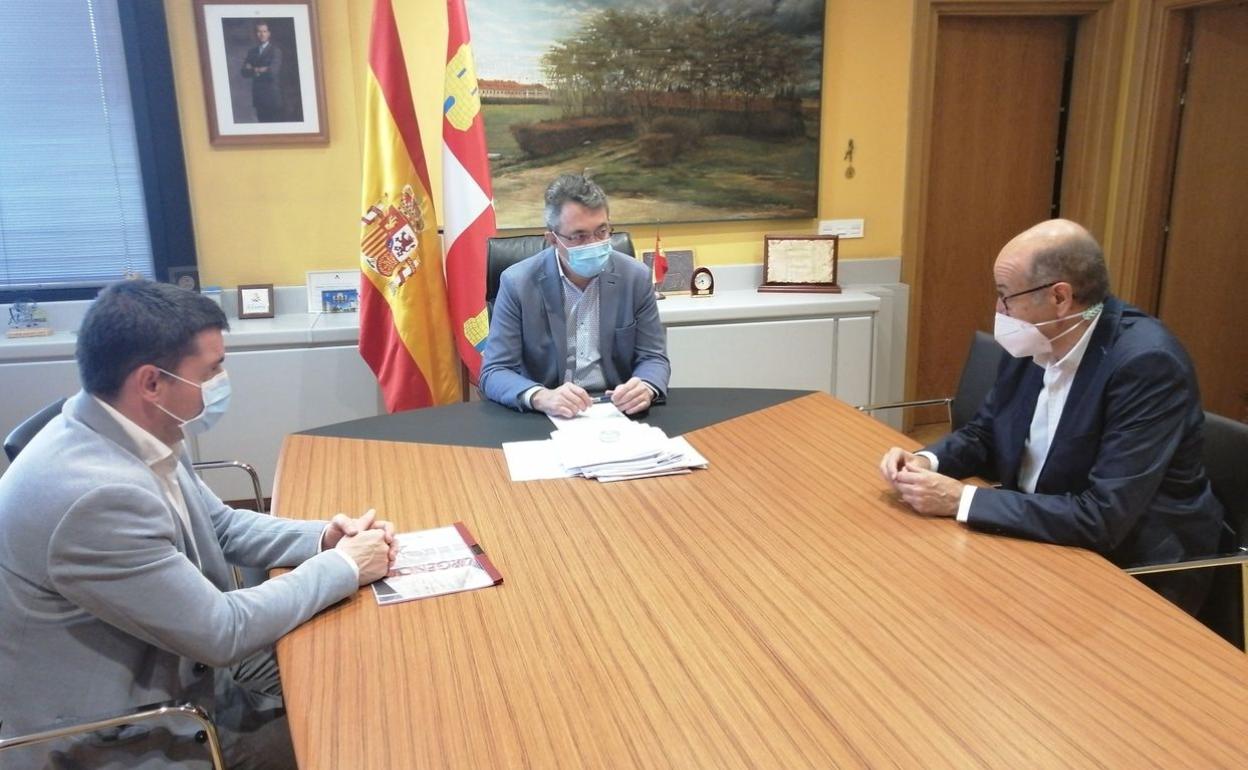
[1107,0,1228,311]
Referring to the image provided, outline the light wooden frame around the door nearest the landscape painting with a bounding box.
[901,0,1133,398]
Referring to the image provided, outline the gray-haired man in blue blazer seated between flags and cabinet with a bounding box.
[480,173,671,417]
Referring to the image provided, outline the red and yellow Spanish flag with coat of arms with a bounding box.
[359,0,459,412]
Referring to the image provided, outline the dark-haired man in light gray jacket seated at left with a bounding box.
[0,281,396,768]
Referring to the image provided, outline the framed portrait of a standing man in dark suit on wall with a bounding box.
[195,0,329,146]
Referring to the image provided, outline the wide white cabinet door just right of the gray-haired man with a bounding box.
[668,318,833,394]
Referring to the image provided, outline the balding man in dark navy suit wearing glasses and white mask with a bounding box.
[880,220,1224,612]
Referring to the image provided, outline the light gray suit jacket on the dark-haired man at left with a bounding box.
[0,393,357,768]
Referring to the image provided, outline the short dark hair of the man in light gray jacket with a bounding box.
[76,280,230,398]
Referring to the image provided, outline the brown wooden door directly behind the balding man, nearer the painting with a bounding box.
[915,16,1075,424]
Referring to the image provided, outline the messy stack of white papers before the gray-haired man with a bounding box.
[503,403,706,482]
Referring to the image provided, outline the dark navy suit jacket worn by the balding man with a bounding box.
[929,297,1224,579]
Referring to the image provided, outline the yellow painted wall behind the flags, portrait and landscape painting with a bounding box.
[165,0,912,287]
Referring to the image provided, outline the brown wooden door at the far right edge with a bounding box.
[1158,4,1248,421]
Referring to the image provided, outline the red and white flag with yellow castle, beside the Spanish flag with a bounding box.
[442,0,494,382]
